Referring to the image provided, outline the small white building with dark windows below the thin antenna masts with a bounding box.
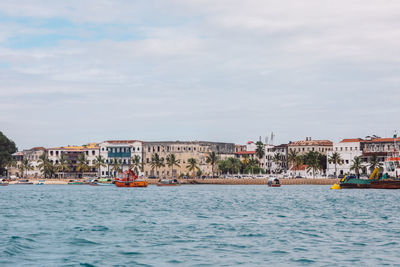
[264,144,288,174]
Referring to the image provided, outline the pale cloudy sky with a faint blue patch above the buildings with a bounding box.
[0,0,400,149]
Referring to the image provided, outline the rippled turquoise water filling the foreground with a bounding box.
[0,185,400,266]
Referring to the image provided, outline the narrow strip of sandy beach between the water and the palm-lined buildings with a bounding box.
[9,178,340,185]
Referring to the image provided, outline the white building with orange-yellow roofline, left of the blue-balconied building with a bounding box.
[47,143,100,178]
